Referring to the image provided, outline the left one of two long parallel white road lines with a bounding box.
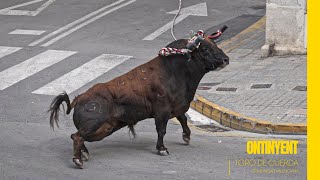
[29,0,126,46]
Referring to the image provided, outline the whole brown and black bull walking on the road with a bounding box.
[49,38,229,167]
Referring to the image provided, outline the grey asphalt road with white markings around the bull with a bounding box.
[0,0,306,179]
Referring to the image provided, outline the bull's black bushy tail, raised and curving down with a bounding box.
[48,92,72,129]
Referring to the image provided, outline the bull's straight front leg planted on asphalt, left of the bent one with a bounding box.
[155,114,169,156]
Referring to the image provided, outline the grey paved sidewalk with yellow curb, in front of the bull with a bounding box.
[191,16,307,134]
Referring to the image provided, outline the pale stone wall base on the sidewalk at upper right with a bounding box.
[262,0,307,56]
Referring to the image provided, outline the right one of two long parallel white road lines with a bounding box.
[41,0,136,47]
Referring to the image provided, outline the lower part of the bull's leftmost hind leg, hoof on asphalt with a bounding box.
[71,131,84,168]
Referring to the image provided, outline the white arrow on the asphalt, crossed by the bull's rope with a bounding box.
[143,2,208,41]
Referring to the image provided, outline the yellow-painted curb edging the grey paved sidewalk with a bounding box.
[190,16,307,135]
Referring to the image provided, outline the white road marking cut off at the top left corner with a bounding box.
[0,0,55,16]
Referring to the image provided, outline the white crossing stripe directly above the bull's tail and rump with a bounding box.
[32,54,132,95]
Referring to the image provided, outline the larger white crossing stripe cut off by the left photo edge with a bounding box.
[0,50,76,90]
